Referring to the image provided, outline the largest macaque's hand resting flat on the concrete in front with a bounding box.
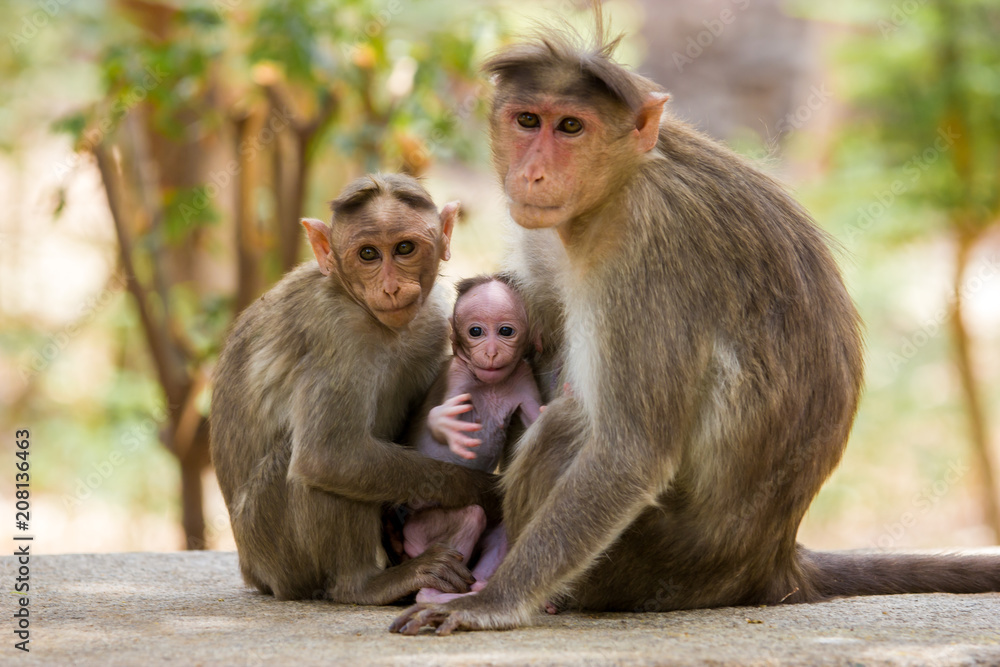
[389,595,529,636]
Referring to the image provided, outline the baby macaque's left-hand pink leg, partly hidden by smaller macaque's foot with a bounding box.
[403,505,486,602]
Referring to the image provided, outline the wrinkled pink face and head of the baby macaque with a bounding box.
[452,281,529,384]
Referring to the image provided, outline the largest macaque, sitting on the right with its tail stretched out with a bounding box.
[392,11,1000,634]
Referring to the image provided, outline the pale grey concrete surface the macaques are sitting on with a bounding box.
[0,552,1000,667]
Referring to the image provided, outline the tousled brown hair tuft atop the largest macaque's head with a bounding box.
[482,0,662,111]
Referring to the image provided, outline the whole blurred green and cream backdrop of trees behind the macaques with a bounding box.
[0,0,1000,553]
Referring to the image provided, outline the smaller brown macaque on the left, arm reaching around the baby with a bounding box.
[211,175,492,604]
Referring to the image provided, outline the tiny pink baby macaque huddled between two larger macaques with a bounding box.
[403,276,541,602]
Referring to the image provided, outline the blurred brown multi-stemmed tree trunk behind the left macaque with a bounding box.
[89,0,337,549]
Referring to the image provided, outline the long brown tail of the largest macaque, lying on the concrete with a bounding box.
[799,549,1000,599]
